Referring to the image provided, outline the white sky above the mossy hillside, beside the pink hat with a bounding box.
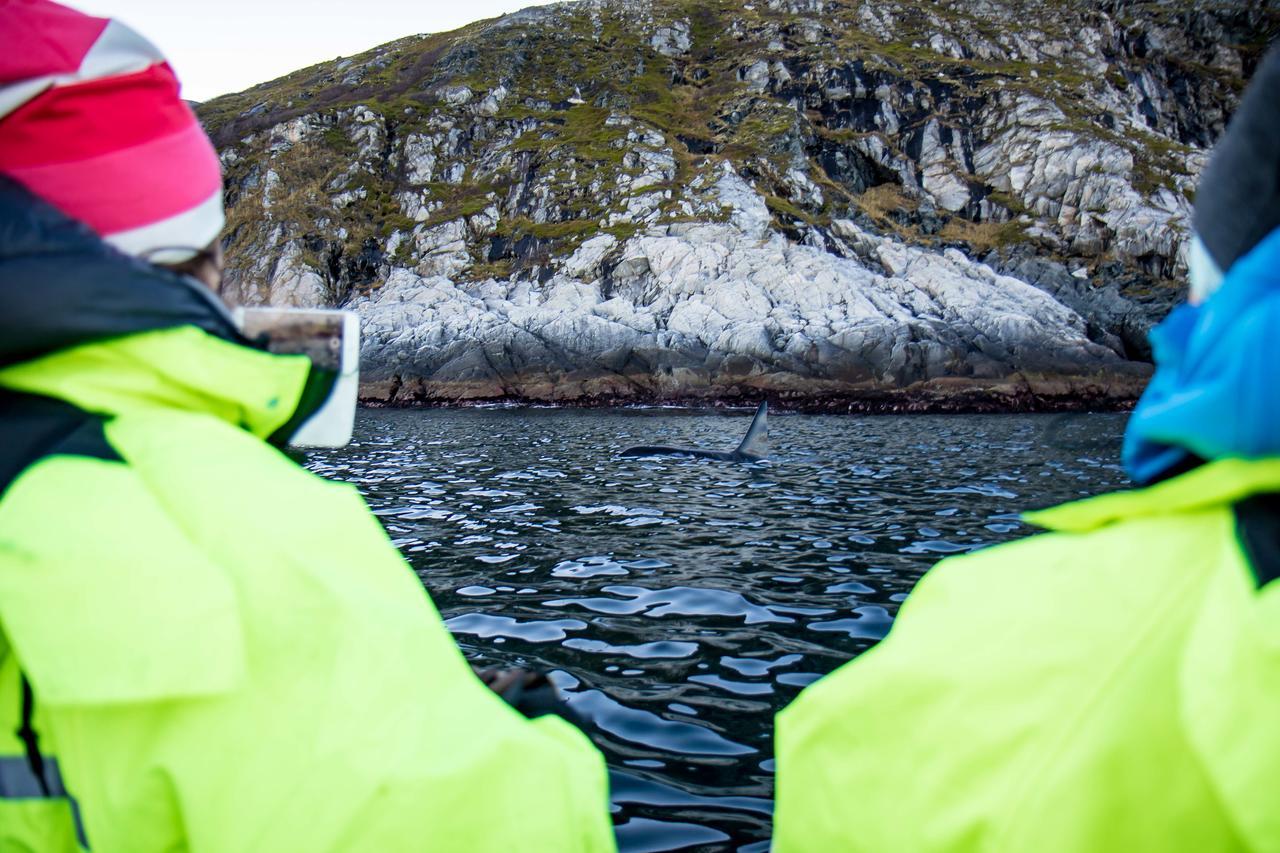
[61,0,563,101]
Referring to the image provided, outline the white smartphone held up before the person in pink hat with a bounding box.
[232,307,360,447]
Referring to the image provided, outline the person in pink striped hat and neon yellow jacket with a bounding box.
[0,0,614,852]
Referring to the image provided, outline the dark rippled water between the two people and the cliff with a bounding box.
[310,410,1125,850]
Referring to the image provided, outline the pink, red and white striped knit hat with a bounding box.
[0,0,224,264]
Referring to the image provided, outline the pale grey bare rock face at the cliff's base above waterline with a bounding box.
[351,173,1142,401]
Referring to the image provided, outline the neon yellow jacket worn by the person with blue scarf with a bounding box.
[774,459,1280,853]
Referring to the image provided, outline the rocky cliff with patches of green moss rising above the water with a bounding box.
[198,0,1280,409]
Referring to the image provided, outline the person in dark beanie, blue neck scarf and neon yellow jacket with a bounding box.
[774,51,1280,853]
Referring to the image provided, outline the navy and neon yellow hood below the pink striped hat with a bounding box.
[0,177,332,441]
